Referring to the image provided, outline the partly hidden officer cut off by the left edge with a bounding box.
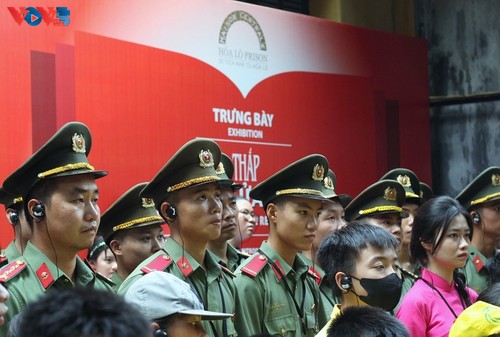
[0,188,31,266]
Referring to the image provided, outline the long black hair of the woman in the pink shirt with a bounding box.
[410,195,474,306]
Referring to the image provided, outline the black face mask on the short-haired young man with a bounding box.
[351,273,403,311]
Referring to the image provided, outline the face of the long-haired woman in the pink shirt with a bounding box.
[424,214,470,272]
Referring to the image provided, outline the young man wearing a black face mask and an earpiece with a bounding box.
[316,219,402,337]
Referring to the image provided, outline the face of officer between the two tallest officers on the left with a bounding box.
[110,225,165,273]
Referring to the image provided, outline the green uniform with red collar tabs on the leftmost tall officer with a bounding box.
[0,242,113,336]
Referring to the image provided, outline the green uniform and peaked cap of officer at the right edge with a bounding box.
[456,166,500,293]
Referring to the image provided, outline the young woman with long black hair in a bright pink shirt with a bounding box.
[396,196,477,337]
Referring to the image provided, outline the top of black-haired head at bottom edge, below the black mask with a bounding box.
[326,306,410,337]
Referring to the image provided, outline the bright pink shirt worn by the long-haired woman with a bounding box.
[396,268,477,337]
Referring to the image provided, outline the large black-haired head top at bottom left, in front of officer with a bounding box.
[18,288,151,337]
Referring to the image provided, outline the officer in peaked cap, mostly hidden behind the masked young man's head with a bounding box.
[345,179,407,242]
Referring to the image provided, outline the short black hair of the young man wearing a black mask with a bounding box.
[316,219,399,296]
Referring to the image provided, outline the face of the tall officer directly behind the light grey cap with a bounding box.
[174,183,222,242]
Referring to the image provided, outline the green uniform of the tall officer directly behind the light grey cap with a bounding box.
[118,239,237,337]
